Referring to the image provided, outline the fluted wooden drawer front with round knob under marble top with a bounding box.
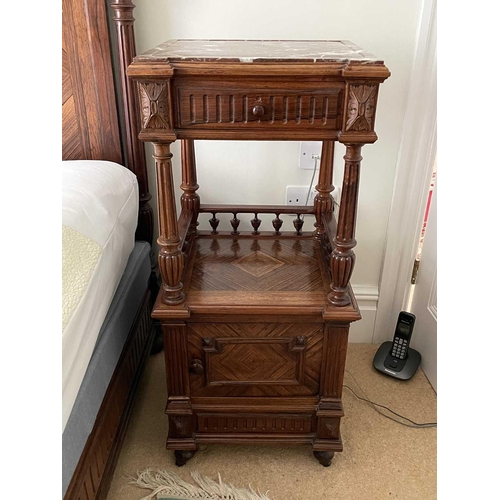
[174,79,344,130]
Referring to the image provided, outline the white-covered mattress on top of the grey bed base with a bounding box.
[62,160,139,431]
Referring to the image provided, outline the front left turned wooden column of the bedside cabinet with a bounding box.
[153,142,184,305]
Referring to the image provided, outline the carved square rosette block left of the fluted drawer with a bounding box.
[139,83,170,129]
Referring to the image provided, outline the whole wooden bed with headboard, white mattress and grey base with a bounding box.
[62,0,158,500]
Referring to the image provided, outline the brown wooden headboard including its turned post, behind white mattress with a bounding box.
[62,0,153,243]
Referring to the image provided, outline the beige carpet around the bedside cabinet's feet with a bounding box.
[108,344,437,500]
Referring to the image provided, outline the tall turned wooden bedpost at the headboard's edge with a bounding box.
[111,0,154,244]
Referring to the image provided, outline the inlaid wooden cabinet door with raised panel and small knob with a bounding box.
[188,323,324,397]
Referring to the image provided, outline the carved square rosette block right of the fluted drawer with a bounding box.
[345,85,378,132]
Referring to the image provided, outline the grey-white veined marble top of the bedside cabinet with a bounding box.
[135,39,383,64]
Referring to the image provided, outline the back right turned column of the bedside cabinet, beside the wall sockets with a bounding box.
[314,141,335,239]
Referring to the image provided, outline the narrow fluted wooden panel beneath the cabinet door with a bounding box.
[197,413,313,434]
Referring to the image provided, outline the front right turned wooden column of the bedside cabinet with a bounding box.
[328,144,363,306]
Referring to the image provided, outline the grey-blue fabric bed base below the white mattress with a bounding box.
[62,241,151,496]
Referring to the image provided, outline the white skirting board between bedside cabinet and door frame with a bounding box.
[349,284,378,344]
